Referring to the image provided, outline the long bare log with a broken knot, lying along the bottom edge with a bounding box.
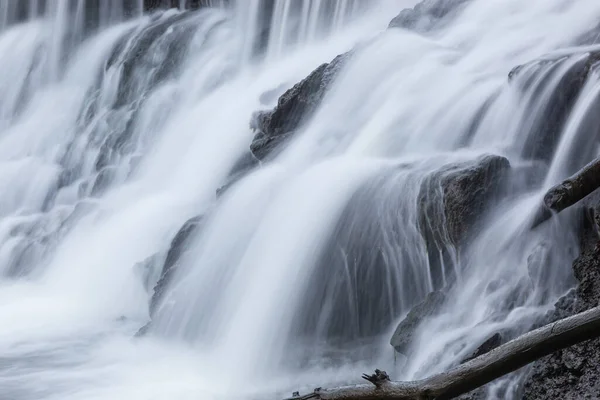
[287,307,600,400]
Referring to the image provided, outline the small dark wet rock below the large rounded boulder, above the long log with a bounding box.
[390,291,446,356]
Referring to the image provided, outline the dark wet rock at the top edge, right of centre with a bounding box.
[389,0,471,33]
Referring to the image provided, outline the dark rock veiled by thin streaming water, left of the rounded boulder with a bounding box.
[293,169,431,348]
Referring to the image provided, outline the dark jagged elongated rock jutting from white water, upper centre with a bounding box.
[250,53,350,160]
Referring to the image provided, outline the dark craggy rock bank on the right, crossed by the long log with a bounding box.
[522,209,600,400]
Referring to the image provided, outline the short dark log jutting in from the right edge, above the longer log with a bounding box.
[532,158,600,228]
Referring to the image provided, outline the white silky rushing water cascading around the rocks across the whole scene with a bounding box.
[0,0,600,400]
